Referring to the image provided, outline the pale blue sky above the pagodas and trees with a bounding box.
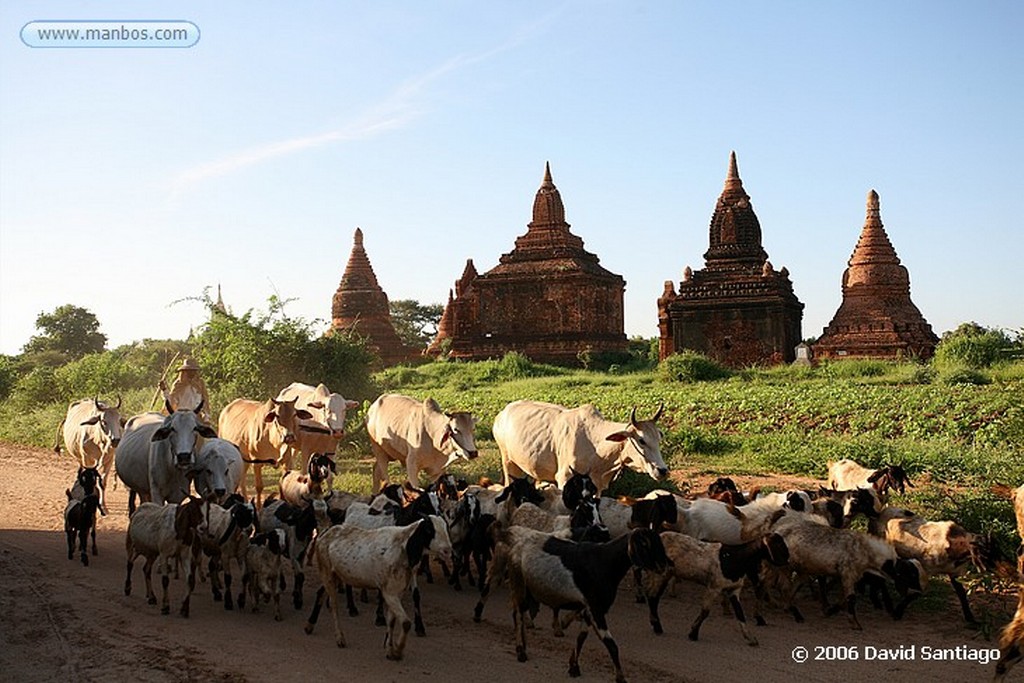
[0,0,1024,354]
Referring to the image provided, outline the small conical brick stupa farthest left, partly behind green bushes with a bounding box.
[331,228,416,366]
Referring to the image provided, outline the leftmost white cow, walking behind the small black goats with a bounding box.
[53,398,124,487]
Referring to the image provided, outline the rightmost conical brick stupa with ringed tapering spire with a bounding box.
[812,189,939,359]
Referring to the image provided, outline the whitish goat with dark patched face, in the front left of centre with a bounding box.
[305,515,452,659]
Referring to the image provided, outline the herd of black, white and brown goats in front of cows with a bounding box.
[58,397,1024,681]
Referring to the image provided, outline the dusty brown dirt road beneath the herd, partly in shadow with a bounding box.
[0,444,1024,683]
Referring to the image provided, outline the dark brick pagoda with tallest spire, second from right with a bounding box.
[657,152,804,368]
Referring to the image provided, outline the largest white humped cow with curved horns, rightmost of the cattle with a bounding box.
[494,400,669,495]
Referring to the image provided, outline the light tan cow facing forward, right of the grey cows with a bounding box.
[217,398,312,507]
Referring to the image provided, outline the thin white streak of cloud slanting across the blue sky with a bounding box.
[171,11,557,198]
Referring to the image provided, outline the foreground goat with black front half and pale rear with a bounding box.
[496,526,669,683]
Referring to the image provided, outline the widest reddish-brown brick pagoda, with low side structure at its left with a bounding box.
[427,165,627,365]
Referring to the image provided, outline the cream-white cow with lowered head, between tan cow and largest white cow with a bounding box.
[367,393,477,494]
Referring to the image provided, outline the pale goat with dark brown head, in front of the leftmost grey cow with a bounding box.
[125,498,203,616]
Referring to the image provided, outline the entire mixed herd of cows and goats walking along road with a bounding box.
[51,383,1024,681]
